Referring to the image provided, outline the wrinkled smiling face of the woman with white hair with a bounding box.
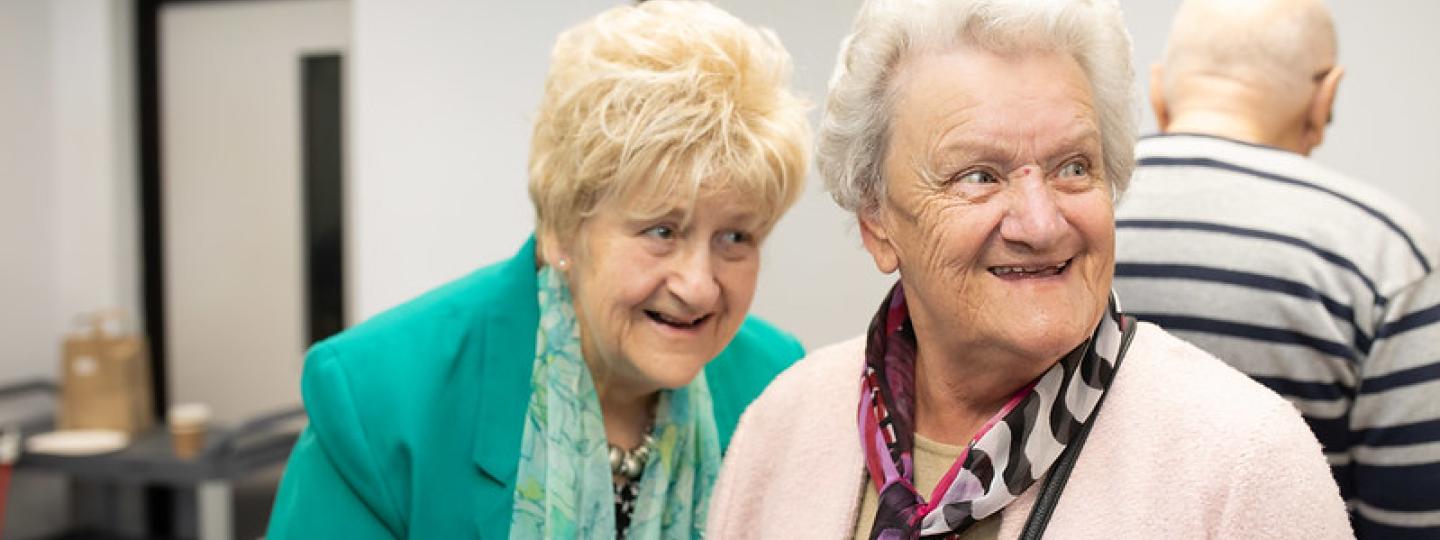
[861,49,1115,361]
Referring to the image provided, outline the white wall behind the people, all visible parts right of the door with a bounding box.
[350,0,1440,347]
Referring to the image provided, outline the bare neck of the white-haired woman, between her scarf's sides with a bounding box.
[914,347,1054,446]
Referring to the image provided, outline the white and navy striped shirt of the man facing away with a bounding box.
[1115,135,1440,539]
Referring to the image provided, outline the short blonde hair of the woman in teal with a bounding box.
[530,0,811,244]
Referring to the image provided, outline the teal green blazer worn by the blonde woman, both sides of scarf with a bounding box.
[268,239,804,540]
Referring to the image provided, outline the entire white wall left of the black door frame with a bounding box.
[0,0,140,383]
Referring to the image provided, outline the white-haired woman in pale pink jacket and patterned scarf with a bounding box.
[708,0,1349,539]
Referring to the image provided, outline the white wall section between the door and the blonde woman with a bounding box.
[346,0,613,321]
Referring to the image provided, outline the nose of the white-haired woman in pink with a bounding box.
[999,167,1068,251]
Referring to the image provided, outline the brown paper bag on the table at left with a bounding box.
[58,311,154,436]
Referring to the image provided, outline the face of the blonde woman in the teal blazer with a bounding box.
[547,188,768,395]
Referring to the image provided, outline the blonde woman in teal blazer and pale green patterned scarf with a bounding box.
[269,0,809,539]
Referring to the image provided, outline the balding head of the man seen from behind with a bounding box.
[1151,0,1345,154]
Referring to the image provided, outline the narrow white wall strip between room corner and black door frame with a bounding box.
[49,0,143,347]
